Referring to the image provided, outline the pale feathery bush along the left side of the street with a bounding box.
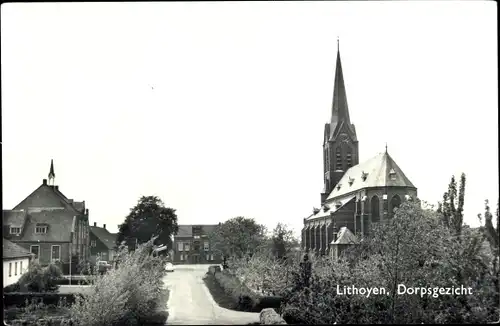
[70,238,170,326]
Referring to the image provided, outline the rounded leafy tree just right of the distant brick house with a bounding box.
[209,216,266,258]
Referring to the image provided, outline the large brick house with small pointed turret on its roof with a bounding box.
[2,162,90,273]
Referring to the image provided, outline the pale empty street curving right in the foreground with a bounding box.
[164,265,259,325]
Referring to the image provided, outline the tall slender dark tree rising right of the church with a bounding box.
[438,173,466,235]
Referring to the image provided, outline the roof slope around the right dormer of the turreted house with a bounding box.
[20,210,75,242]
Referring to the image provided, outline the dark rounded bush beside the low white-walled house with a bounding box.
[18,262,63,292]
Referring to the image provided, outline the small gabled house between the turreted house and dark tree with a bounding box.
[90,222,117,262]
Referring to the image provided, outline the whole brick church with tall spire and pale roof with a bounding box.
[301,41,417,257]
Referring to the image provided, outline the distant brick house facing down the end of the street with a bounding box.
[172,224,222,264]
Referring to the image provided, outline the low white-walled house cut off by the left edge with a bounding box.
[3,239,32,287]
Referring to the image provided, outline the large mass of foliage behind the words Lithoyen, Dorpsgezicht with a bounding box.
[283,201,498,324]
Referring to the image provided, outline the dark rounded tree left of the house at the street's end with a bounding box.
[116,196,179,248]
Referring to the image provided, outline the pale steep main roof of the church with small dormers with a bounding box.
[326,152,415,202]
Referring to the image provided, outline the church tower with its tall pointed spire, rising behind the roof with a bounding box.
[321,39,359,204]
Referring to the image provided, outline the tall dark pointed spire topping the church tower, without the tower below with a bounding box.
[330,37,351,135]
